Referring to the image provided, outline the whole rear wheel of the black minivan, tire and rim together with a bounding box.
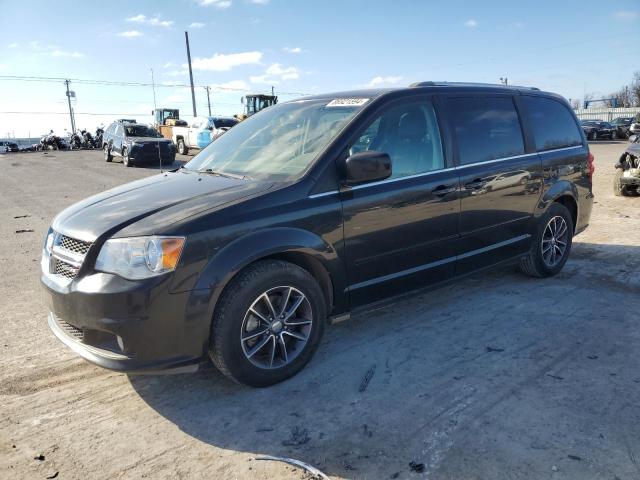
[520,203,574,277]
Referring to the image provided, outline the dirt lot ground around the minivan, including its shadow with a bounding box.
[0,142,640,480]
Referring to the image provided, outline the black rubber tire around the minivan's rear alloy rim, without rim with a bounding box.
[520,202,574,278]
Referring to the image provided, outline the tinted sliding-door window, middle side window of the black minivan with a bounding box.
[448,97,524,165]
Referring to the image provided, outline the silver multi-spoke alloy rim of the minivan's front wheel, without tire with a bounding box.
[240,286,313,369]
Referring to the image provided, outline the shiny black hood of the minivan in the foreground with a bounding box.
[52,169,273,242]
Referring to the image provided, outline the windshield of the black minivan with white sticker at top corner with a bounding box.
[185,99,366,181]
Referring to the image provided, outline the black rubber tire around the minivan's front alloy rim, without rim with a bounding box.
[209,260,327,387]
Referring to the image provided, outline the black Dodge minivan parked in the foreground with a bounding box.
[42,82,594,386]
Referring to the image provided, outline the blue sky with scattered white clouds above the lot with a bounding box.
[0,0,640,137]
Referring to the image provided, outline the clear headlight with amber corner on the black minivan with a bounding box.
[96,236,185,280]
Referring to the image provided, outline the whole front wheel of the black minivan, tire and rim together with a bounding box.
[209,260,327,387]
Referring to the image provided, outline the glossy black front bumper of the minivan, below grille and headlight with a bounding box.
[42,273,210,373]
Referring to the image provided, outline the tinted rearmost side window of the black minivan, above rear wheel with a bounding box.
[522,96,582,151]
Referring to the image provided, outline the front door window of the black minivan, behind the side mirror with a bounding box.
[349,100,444,178]
